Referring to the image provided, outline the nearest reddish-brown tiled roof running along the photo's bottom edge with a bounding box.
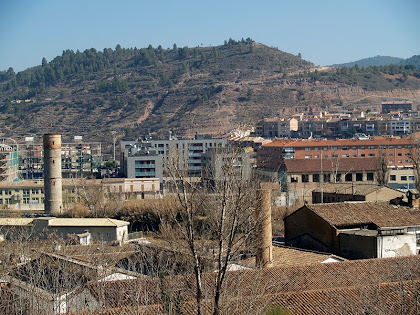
[79,260,420,315]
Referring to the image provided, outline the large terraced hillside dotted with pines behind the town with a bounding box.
[0,39,420,151]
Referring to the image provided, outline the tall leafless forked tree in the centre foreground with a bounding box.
[161,148,258,314]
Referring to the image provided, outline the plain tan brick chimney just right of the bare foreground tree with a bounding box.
[255,189,273,268]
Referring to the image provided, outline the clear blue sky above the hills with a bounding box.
[0,0,420,71]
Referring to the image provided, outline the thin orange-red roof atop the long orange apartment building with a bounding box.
[263,137,412,147]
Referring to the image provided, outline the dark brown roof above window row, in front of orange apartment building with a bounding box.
[284,158,378,173]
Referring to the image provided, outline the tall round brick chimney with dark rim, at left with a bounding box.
[43,133,63,215]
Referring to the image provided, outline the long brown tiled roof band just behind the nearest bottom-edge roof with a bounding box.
[89,255,420,308]
